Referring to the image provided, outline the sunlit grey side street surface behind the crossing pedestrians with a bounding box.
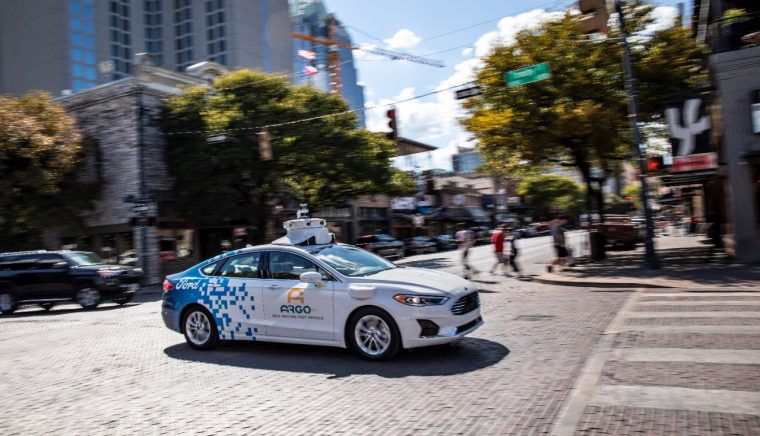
[396,231,588,275]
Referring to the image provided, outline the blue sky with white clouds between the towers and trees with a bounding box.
[324,0,678,169]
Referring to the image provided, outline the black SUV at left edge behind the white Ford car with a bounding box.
[0,250,142,314]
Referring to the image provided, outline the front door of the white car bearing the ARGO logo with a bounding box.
[263,251,335,341]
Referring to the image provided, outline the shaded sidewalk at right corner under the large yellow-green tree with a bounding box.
[532,236,760,289]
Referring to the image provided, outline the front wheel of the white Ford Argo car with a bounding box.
[346,307,401,361]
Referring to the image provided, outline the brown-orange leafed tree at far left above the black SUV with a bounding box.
[0,92,97,250]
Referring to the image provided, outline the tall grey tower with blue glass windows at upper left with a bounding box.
[0,0,293,95]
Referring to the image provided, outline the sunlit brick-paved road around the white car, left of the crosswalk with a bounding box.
[0,278,628,435]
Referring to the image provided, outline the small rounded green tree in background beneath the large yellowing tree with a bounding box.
[517,174,583,220]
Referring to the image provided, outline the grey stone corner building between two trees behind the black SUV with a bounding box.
[45,63,211,283]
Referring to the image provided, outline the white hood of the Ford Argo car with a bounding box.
[351,267,476,295]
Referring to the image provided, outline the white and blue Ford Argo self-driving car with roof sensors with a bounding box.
[162,206,483,360]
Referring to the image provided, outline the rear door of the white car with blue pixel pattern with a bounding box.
[204,252,265,339]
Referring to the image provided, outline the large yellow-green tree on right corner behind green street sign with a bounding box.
[463,0,704,215]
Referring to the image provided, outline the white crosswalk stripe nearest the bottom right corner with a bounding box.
[590,385,760,415]
